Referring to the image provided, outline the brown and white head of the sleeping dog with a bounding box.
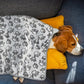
[52,25,83,55]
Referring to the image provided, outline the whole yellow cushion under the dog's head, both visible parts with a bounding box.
[41,15,67,69]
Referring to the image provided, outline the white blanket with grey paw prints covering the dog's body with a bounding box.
[0,15,53,80]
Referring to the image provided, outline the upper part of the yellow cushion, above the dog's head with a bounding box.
[41,15,64,28]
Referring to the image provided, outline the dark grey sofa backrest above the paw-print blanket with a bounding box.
[0,0,63,19]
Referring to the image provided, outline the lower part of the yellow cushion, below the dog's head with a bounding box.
[47,49,68,70]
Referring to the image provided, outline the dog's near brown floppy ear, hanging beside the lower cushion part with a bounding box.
[54,36,67,53]
